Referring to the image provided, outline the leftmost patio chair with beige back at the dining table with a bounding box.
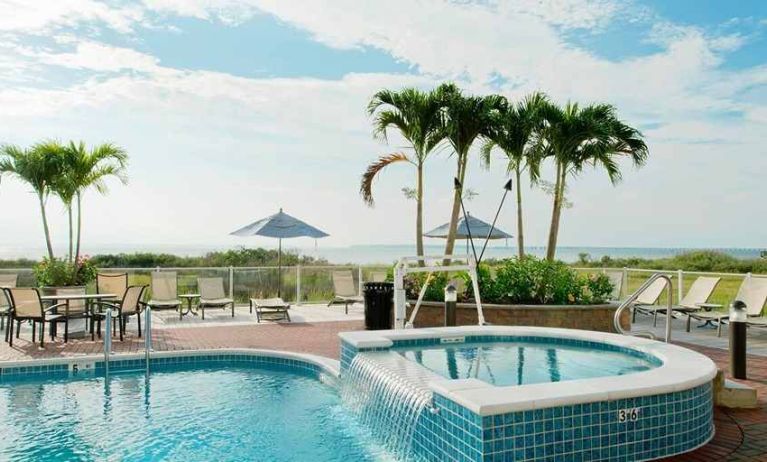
[2,287,66,346]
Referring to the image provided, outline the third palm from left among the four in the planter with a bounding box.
[482,92,547,259]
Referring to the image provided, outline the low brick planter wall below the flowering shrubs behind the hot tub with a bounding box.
[407,300,631,332]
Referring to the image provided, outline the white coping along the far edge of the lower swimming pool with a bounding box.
[0,348,340,377]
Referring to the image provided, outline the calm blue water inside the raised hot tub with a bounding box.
[397,342,660,386]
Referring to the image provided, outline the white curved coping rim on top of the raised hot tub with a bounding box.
[339,326,717,416]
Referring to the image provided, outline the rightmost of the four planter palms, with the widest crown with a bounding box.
[538,103,648,260]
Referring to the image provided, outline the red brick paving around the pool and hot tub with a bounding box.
[0,320,767,462]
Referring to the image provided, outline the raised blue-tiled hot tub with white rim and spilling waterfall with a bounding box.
[340,326,716,461]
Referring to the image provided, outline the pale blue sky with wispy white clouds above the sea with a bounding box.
[0,0,767,252]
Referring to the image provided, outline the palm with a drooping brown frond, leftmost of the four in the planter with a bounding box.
[360,88,442,256]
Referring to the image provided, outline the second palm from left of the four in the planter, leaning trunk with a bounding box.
[436,83,506,264]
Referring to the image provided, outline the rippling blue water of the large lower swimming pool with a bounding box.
[0,368,389,462]
